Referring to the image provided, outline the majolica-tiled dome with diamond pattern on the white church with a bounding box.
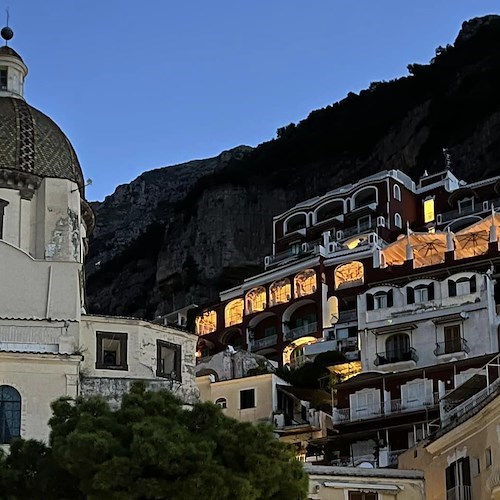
[0,96,83,188]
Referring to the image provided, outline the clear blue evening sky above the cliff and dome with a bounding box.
[0,0,499,200]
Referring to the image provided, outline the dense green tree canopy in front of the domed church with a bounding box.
[0,384,307,500]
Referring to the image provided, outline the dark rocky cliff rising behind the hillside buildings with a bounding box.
[87,16,500,318]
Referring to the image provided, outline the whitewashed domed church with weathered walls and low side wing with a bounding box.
[0,30,198,444]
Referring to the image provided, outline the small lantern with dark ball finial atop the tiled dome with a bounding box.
[0,26,28,99]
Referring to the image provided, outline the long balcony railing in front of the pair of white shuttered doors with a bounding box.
[333,392,439,422]
